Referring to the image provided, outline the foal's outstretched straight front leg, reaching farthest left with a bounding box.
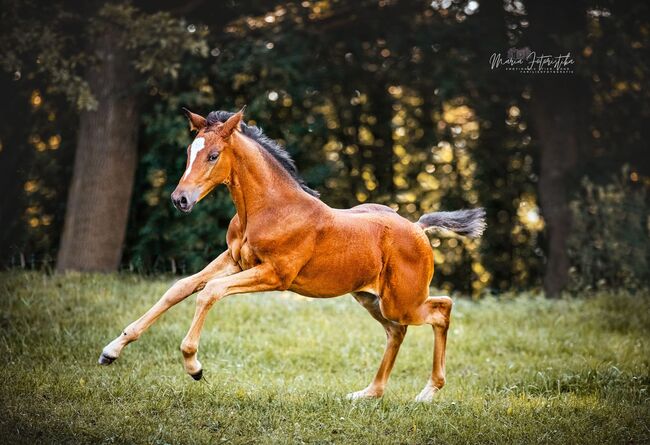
[99,250,241,365]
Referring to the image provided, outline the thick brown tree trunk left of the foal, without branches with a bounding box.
[57,26,138,272]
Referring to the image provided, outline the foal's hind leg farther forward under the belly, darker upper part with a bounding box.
[348,292,407,400]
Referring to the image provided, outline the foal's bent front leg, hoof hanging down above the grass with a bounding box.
[181,264,280,380]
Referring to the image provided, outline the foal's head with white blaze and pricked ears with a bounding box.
[172,109,244,213]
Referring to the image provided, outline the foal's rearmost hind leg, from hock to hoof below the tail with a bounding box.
[410,297,453,402]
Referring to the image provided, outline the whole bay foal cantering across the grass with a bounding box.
[99,110,484,401]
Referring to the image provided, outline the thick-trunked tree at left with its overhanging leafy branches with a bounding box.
[3,1,207,271]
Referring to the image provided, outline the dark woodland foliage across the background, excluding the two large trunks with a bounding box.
[0,0,650,296]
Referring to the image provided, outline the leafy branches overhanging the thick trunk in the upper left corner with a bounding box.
[0,0,208,110]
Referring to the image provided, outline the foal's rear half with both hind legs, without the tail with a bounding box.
[290,204,452,401]
